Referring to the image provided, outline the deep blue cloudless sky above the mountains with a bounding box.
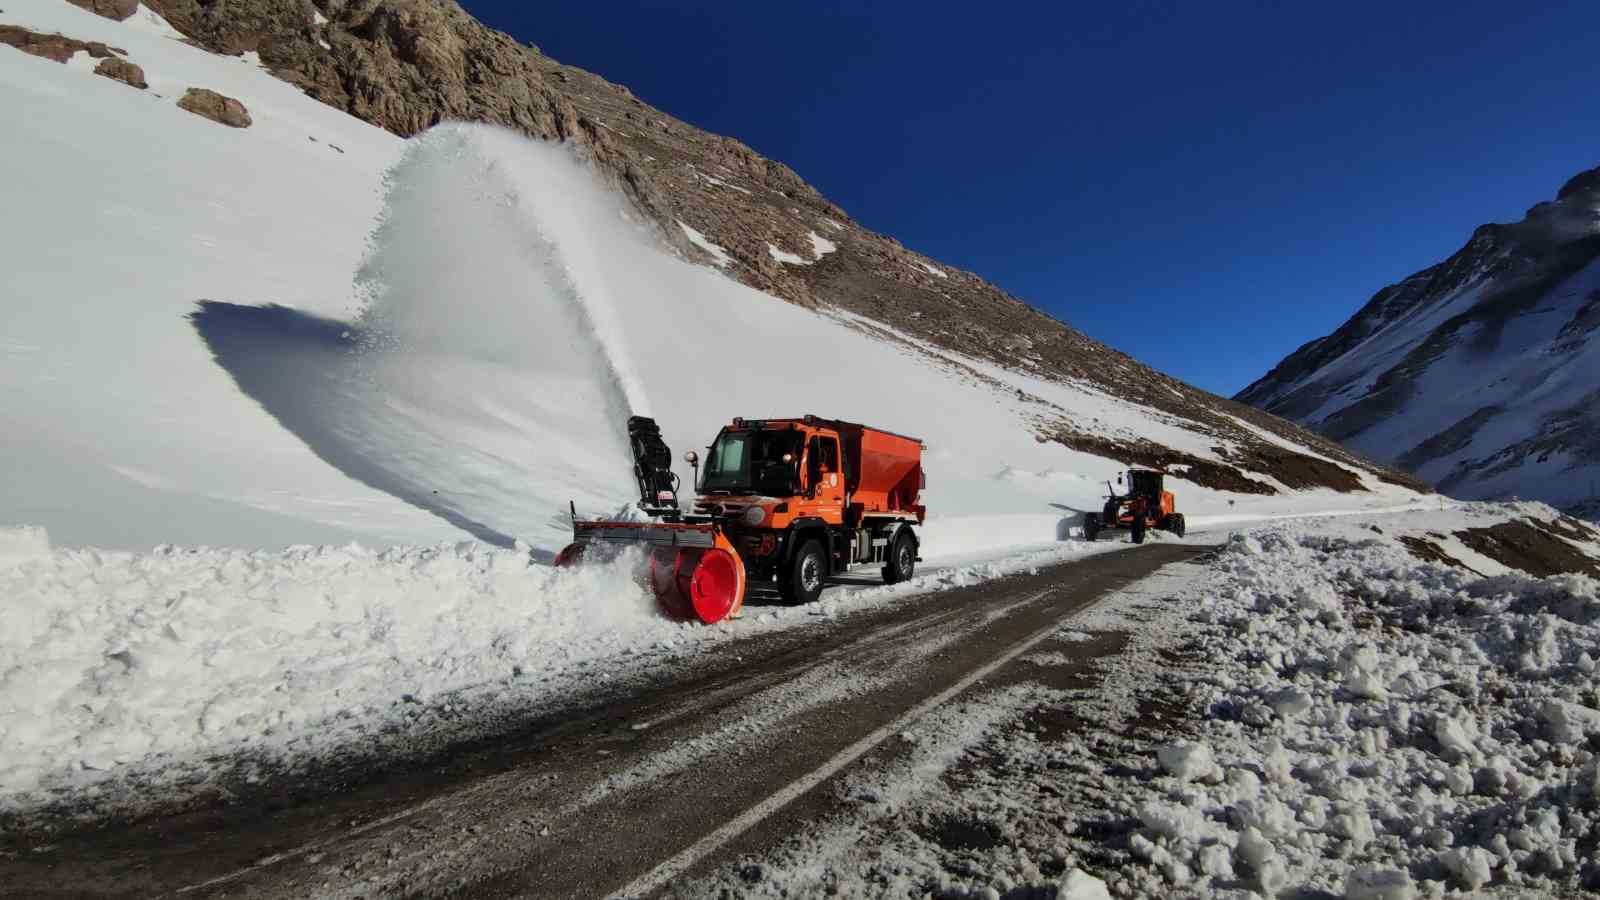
[464,0,1600,394]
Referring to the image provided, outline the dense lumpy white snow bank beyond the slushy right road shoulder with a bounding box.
[1075,509,1600,898]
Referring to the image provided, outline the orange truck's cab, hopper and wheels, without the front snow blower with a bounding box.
[685,416,926,602]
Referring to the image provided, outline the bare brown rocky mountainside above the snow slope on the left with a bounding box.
[131,0,1419,493]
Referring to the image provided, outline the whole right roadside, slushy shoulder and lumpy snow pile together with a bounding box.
[680,503,1600,900]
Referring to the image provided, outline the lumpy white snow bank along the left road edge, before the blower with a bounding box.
[0,530,665,807]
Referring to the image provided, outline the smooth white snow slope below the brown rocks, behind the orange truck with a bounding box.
[0,0,1410,556]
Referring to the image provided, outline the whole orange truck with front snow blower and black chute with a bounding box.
[555,416,926,625]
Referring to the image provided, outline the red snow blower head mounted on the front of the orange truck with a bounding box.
[555,522,746,625]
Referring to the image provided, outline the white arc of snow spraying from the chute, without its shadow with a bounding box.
[358,125,650,416]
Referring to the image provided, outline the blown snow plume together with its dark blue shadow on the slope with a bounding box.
[192,125,659,547]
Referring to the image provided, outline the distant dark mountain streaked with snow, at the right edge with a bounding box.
[1237,170,1600,508]
